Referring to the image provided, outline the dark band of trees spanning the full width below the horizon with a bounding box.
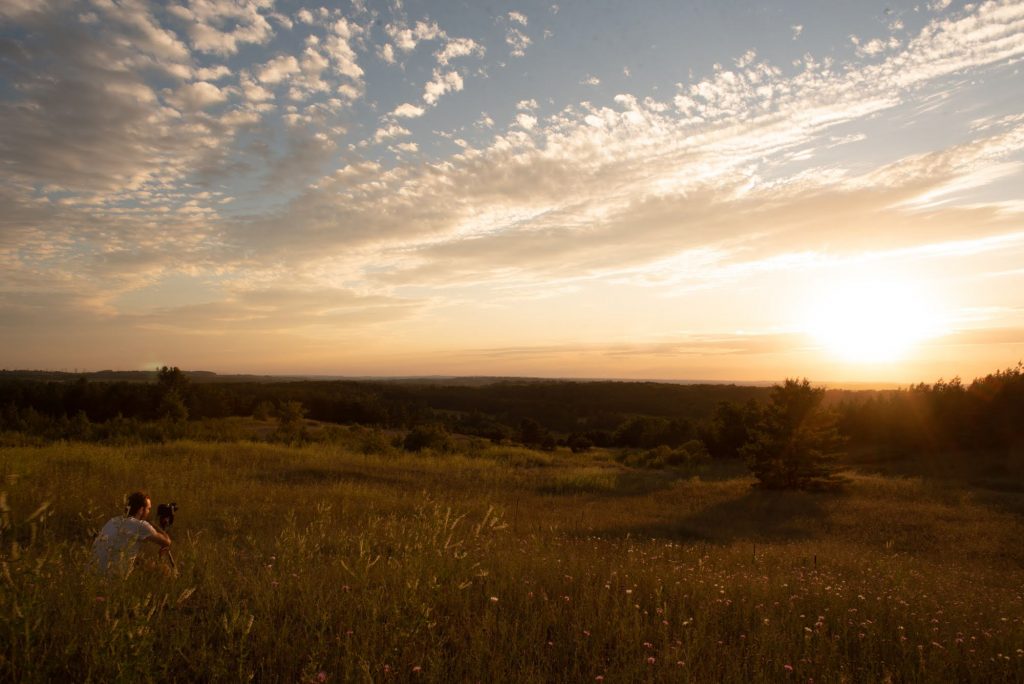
[0,365,1024,475]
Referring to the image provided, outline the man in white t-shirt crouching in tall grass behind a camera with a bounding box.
[92,491,171,578]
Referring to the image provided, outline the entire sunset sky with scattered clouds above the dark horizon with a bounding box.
[0,0,1024,383]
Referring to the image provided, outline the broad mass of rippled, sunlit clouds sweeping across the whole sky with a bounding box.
[6,3,1024,368]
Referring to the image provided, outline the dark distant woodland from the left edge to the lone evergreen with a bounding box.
[0,368,768,448]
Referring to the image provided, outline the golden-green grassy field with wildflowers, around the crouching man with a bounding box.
[0,435,1024,682]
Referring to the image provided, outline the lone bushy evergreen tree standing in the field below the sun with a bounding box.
[740,379,844,489]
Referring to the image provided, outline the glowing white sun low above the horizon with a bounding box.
[807,279,942,364]
